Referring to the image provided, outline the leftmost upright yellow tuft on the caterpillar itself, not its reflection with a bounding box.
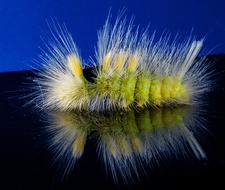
[67,54,83,77]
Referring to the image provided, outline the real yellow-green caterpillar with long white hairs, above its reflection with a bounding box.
[32,17,211,111]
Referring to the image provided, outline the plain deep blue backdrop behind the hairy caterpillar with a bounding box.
[0,0,225,71]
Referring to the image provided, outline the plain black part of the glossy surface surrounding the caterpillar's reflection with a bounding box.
[0,56,225,190]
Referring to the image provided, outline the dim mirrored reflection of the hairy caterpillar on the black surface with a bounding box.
[49,106,205,180]
